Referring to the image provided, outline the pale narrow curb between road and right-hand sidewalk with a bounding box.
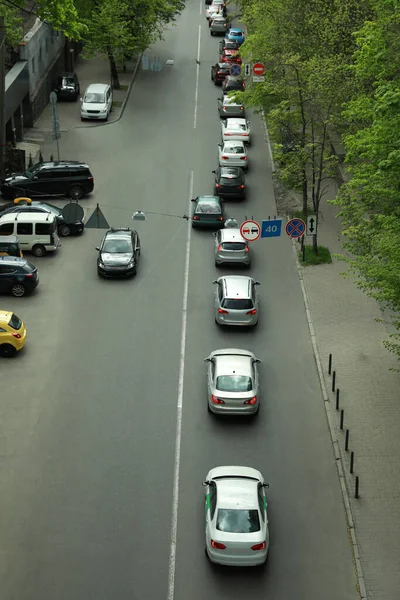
[261,110,368,600]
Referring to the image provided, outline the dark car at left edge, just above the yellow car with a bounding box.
[0,256,39,298]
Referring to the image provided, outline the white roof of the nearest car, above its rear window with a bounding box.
[216,477,258,510]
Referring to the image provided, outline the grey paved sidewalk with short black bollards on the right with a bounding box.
[284,171,400,600]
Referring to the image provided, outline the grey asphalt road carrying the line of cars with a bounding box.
[0,0,356,600]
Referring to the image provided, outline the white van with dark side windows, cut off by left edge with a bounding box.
[0,212,61,256]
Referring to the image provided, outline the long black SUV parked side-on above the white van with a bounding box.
[0,160,94,200]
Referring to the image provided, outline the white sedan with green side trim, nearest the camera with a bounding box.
[203,466,269,567]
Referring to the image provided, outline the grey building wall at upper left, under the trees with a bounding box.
[20,19,65,127]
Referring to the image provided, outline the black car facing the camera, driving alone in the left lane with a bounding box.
[96,228,140,277]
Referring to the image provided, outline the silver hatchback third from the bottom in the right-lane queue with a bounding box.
[213,275,260,327]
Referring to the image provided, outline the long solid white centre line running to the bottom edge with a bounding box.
[167,171,194,600]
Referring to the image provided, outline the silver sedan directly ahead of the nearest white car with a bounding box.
[204,348,261,415]
